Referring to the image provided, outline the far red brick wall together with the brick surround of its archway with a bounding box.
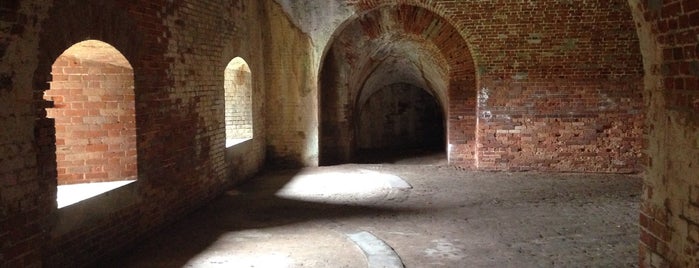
[271,0,644,172]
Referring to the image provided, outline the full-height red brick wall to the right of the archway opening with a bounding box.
[348,0,644,172]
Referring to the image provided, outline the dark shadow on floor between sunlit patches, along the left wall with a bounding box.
[93,170,415,267]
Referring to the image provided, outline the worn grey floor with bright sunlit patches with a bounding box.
[98,156,641,267]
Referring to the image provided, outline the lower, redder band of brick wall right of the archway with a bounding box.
[478,79,643,172]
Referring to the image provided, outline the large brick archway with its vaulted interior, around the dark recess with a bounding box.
[319,5,476,167]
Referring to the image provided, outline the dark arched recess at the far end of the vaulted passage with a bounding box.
[355,83,446,163]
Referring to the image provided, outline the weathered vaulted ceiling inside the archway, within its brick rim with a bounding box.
[333,9,449,111]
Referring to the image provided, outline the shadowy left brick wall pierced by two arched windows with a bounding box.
[0,0,264,267]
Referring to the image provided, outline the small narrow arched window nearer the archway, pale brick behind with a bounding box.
[224,57,253,147]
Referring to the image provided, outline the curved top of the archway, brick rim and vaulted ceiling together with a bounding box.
[322,5,475,113]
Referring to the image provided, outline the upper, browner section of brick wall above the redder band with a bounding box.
[346,0,643,79]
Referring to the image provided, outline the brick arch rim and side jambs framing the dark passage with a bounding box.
[319,4,477,167]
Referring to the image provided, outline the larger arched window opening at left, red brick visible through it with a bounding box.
[44,40,137,208]
